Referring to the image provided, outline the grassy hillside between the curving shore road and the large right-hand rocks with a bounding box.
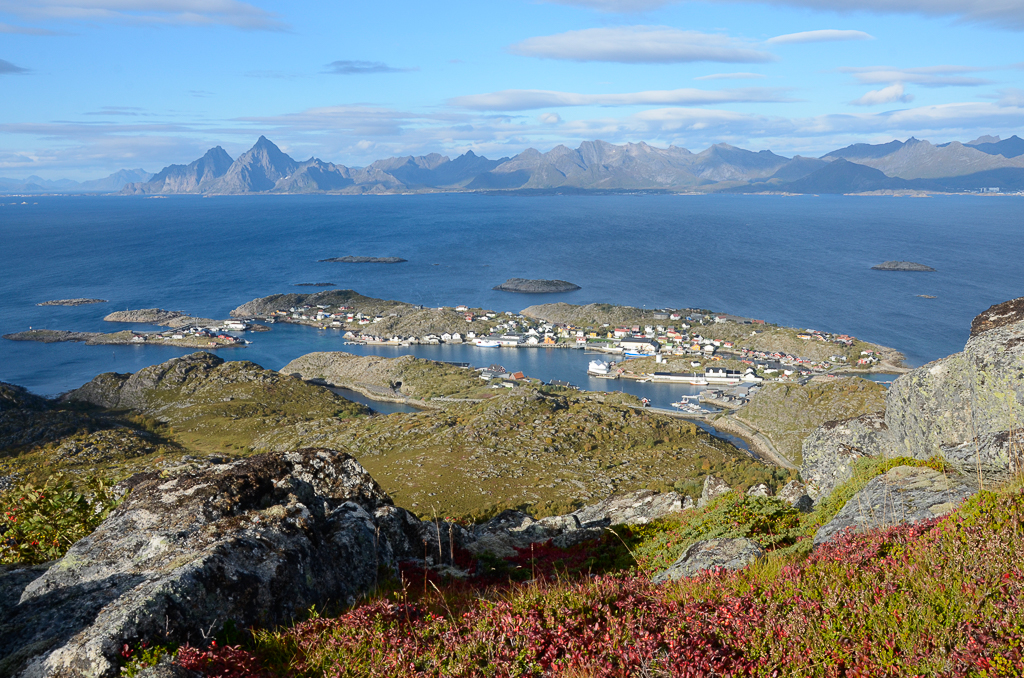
[734,377,886,465]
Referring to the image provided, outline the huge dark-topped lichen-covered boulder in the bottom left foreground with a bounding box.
[0,450,394,676]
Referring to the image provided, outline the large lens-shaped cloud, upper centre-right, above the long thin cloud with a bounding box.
[509,26,775,63]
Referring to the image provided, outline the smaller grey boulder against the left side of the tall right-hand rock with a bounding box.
[800,412,892,501]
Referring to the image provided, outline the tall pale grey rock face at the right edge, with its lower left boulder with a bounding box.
[801,298,1024,498]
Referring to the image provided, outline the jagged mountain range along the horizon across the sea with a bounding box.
[0,135,1024,196]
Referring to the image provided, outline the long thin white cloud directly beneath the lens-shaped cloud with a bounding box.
[447,87,793,111]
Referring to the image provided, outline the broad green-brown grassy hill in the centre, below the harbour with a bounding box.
[257,384,775,519]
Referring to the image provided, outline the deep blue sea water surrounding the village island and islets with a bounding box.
[0,195,1024,404]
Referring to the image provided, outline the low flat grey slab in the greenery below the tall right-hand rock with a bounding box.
[814,466,978,545]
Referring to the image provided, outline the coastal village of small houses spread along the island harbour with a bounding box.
[243,303,902,393]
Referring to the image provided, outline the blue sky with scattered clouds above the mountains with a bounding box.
[0,0,1024,180]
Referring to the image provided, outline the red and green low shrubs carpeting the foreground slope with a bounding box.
[172,491,1024,678]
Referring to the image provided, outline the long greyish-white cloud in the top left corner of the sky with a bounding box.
[0,0,288,31]
